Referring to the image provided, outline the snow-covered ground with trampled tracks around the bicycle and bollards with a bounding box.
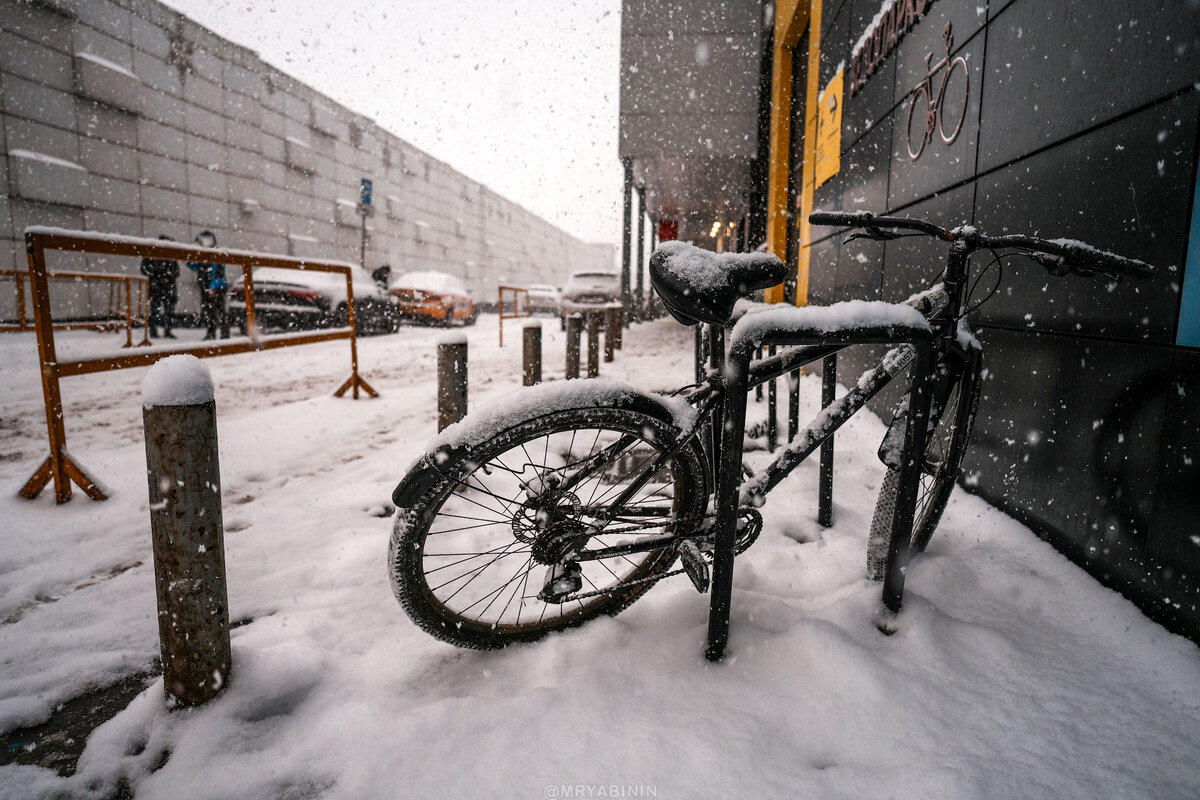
[0,317,1200,800]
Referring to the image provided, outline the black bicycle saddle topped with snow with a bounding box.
[650,241,786,325]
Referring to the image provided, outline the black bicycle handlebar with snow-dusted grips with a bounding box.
[809,211,1158,279]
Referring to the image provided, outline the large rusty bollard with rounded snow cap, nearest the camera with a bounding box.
[142,355,232,708]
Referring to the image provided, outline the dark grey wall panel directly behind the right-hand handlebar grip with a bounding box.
[976,95,1200,343]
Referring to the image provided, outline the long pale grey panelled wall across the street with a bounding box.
[0,0,613,320]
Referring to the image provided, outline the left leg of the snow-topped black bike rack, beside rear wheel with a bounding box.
[704,331,752,661]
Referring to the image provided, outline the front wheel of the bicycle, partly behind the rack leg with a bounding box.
[866,369,980,581]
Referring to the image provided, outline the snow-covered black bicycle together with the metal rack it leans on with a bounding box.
[388,212,1154,660]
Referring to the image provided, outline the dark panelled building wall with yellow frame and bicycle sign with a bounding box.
[623,0,1200,639]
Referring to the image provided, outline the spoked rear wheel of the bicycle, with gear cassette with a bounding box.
[389,408,706,649]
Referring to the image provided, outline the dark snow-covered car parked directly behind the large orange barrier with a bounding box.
[229,267,400,335]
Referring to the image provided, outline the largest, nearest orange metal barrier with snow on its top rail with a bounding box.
[20,227,378,503]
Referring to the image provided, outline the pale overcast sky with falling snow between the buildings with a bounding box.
[166,0,622,242]
